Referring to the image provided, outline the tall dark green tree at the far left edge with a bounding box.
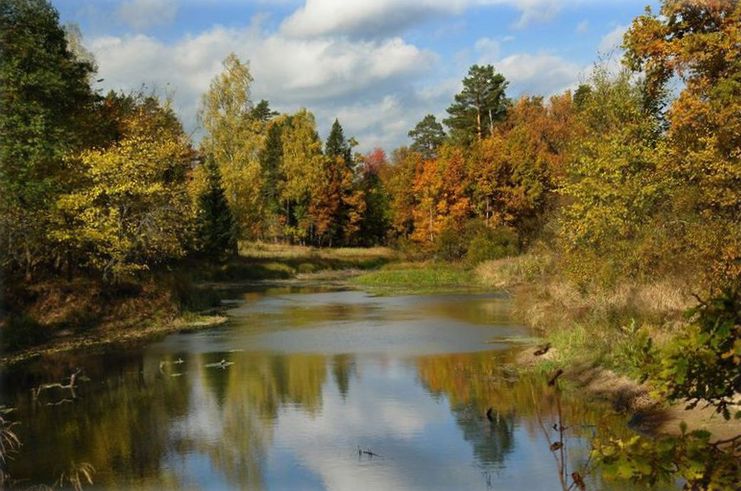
[0,0,95,279]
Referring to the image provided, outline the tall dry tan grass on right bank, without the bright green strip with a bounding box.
[474,254,693,377]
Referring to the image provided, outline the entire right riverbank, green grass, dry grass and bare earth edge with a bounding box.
[352,254,741,439]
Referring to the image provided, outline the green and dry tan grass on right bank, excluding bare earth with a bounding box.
[351,254,696,378]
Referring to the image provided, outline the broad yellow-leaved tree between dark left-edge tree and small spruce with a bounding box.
[50,99,193,280]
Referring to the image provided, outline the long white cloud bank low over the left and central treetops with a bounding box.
[88,22,437,150]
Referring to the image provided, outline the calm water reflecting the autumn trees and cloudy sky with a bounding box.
[2,289,640,490]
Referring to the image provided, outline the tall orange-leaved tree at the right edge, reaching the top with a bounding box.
[625,0,741,283]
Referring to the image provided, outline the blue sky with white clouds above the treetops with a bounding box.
[52,0,656,151]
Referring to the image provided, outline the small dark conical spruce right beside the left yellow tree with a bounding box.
[196,156,237,258]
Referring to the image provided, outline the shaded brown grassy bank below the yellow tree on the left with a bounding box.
[0,271,226,364]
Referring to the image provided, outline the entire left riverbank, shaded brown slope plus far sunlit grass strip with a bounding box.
[0,242,396,365]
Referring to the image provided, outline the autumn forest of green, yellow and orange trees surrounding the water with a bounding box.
[0,0,741,485]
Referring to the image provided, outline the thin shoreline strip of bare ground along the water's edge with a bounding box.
[0,268,741,446]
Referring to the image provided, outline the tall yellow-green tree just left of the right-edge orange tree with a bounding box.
[561,68,666,281]
